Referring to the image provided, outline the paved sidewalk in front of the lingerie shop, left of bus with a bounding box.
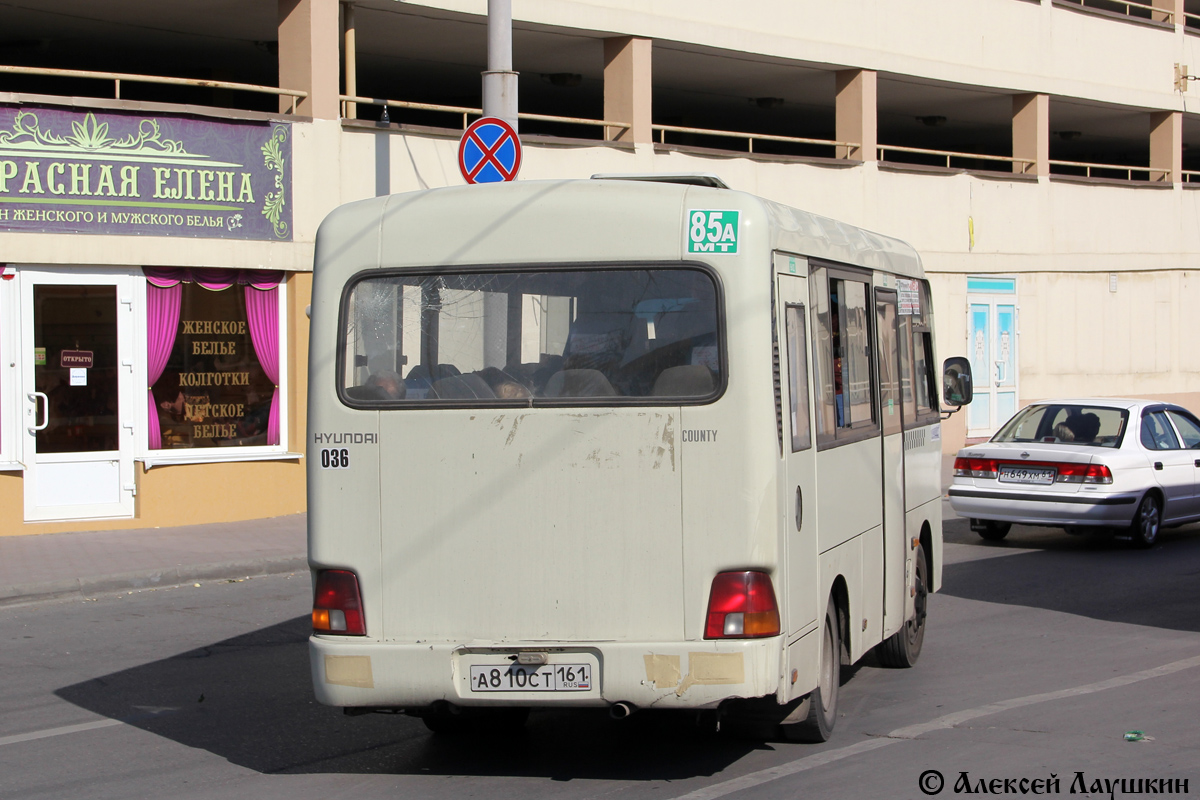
[0,513,308,606]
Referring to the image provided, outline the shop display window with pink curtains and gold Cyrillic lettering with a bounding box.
[144,267,283,450]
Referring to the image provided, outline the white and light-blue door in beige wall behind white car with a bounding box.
[967,278,1019,438]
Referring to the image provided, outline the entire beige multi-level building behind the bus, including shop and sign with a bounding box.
[0,0,1200,534]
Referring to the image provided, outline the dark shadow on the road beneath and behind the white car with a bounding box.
[942,519,1200,631]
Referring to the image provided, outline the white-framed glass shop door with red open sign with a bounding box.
[20,269,136,522]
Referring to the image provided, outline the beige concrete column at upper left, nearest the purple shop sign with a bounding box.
[278,0,340,120]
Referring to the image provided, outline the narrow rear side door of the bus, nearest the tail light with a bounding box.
[775,260,824,647]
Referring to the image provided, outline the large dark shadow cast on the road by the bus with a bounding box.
[55,616,769,781]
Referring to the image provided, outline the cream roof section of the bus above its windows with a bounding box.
[317,176,924,277]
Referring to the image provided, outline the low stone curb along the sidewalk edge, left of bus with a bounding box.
[0,555,308,607]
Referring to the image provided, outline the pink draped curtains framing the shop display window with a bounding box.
[142,266,283,450]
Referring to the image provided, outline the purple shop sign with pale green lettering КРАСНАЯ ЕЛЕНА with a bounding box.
[0,106,292,241]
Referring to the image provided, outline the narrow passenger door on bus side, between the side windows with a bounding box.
[875,289,912,637]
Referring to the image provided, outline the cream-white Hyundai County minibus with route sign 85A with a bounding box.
[307,176,970,740]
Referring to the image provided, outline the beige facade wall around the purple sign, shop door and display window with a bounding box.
[0,0,1200,535]
